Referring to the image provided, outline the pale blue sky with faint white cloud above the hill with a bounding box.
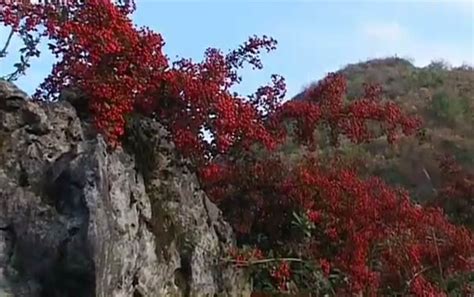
[0,0,474,97]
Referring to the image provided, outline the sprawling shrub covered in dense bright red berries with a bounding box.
[0,0,474,296]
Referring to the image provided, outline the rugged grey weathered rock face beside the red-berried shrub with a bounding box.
[0,81,250,297]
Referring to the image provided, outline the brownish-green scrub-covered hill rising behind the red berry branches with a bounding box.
[294,58,474,200]
